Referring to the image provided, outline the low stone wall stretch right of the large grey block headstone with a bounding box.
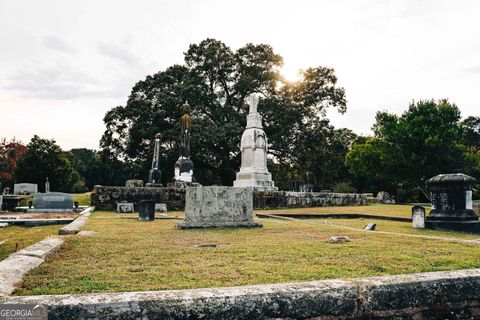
[253,191,367,209]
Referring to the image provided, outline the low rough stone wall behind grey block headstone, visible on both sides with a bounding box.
[90,186,367,210]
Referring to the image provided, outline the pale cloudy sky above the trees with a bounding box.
[0,0,480,150]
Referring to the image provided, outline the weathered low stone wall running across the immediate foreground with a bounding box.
[4,269,480,320]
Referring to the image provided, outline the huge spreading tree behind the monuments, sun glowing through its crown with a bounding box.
[100,39,346,185]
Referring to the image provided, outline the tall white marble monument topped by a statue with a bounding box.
[233,95,277,191]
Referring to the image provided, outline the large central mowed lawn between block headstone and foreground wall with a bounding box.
[15,212,480,295]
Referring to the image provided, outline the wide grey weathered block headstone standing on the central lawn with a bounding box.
[177,186,262,229]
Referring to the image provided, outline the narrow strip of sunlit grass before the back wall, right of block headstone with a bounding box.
[255,203,430,218]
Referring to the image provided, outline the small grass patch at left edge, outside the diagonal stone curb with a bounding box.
[0,225,63,261]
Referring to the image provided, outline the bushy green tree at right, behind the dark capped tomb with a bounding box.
[345,100,466,193]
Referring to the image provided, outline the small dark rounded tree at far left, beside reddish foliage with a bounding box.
[15,135,78,192]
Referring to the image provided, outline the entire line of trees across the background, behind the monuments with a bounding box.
[0,39,480,199]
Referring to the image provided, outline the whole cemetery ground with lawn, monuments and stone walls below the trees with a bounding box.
[0,92,480,319]
